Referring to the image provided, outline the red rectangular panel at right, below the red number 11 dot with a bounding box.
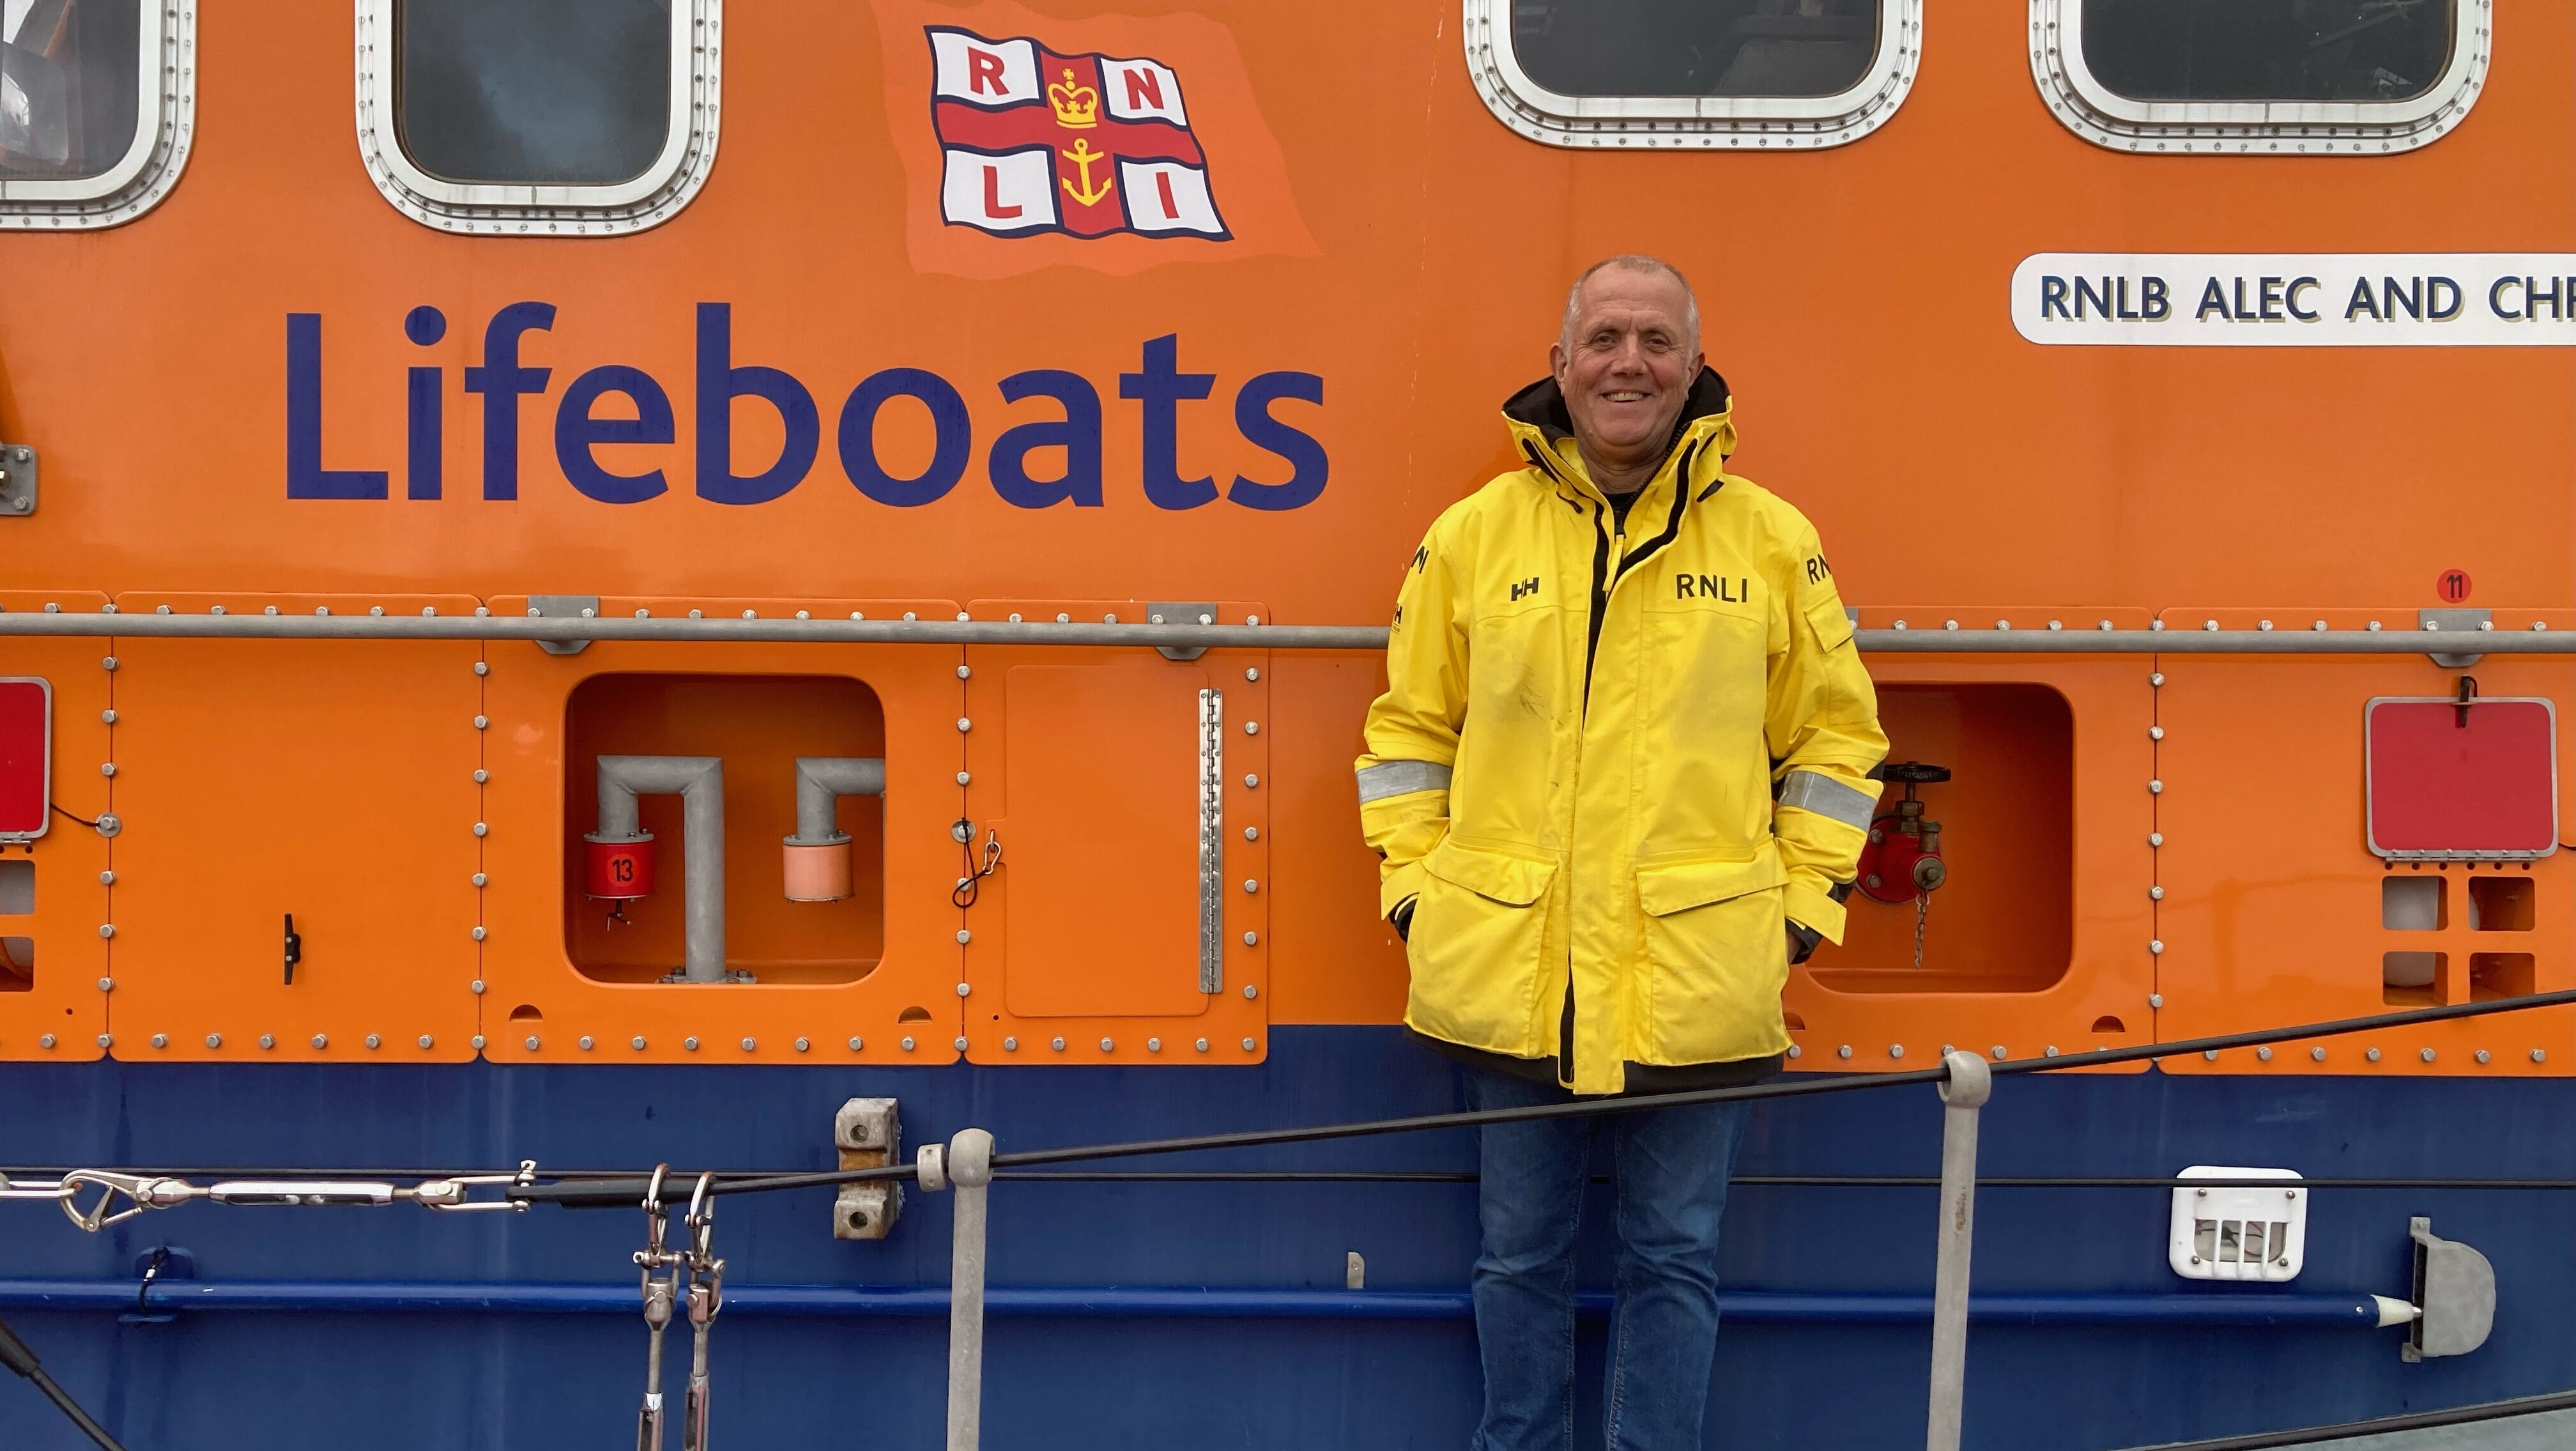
[2365,698,2558,856]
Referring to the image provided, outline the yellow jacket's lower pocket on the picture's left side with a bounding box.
[1404,838,1556,1057]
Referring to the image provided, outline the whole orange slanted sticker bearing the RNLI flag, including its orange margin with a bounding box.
[876,0,1314,279]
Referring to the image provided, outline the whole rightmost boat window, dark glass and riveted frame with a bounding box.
[2032,0,2491,155]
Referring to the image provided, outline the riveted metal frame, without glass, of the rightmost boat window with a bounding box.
[2030,0,2496,157]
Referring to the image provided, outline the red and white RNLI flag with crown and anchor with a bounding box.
[928,26,1231,240]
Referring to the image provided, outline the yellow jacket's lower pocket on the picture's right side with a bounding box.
[1636,843,1788,1064]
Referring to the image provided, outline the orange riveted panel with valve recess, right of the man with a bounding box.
[1782,606,2156,1072]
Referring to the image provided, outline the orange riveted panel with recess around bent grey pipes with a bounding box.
[479,595,963,1064]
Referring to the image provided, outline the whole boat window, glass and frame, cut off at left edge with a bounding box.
[0,0,195,227]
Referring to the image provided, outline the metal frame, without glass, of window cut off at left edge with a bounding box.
[0,0,195,232]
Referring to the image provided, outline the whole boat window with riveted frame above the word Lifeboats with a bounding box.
[358,0,721,234]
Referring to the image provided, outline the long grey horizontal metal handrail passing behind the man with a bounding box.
[0,608,2576,655]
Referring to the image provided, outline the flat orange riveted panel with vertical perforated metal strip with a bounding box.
[961,601,1278,1062]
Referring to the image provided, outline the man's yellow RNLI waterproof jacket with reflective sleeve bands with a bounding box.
[1358,371,1888,1093]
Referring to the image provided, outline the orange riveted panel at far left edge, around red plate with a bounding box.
[0,590,116,1059]
